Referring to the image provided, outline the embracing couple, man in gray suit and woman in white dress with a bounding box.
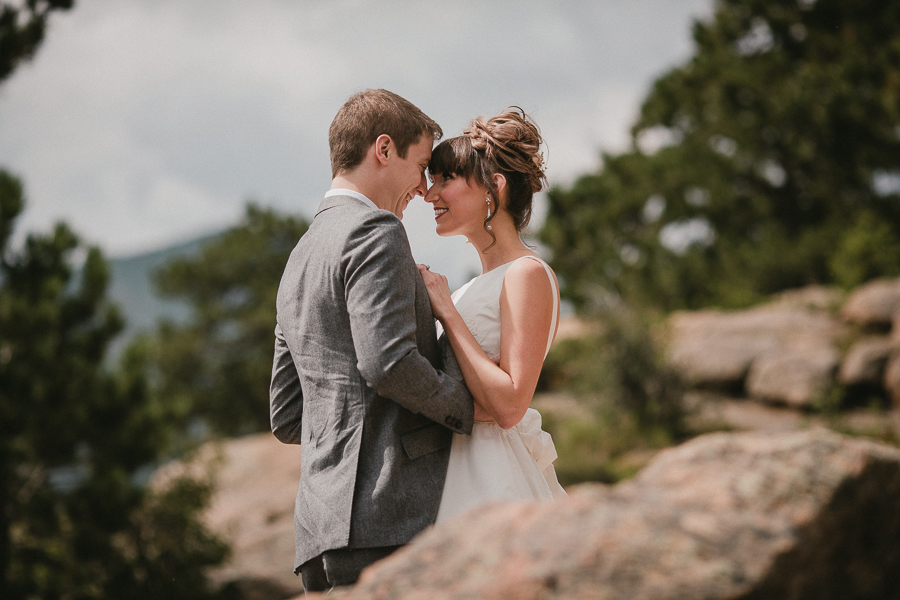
[270,90,565,591]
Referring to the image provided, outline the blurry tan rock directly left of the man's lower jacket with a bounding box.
[154,432,303,600]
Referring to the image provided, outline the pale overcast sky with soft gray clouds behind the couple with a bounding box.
[0,0,712,284]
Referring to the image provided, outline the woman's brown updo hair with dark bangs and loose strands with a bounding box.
[428,106,547,245]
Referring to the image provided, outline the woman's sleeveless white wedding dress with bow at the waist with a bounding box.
[437,257,566,523]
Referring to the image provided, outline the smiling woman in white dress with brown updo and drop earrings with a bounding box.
[419,107,565,523]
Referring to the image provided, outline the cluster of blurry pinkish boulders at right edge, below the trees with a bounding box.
[667,278,900,408]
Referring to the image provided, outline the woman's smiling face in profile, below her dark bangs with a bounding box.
[425,173,495,238]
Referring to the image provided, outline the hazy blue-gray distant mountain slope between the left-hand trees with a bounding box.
[103,233,221,354]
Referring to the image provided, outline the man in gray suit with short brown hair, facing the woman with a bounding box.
[270,90,475,591]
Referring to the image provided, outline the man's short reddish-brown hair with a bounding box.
[328,90,444,177]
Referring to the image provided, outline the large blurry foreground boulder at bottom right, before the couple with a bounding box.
[338,430,900,600]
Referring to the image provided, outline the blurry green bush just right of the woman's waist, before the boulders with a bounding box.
[540,302,687,485]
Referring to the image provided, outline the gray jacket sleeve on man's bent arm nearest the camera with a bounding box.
[344,211,474,434]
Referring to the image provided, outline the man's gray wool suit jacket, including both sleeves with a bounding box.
[270,196,474,570]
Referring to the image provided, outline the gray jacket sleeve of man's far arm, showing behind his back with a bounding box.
[269,325,303,444]
